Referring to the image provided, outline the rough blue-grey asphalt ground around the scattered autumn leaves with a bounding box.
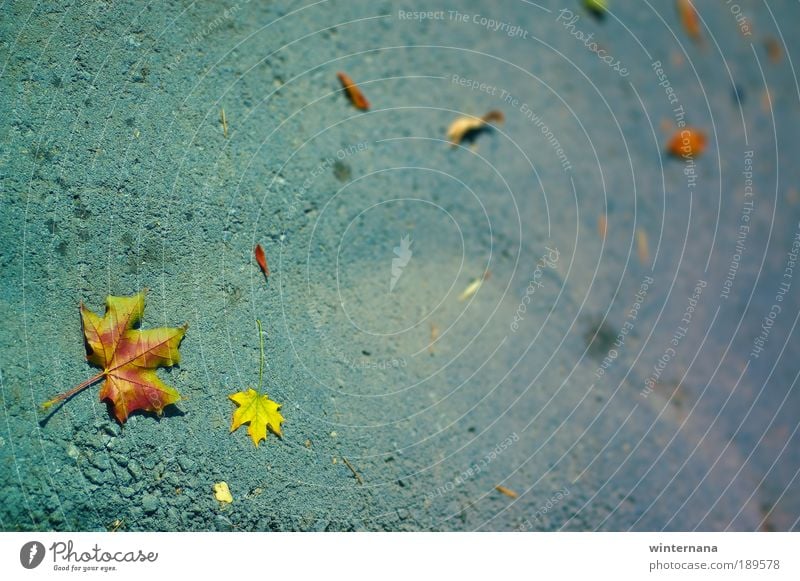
[0,0,800,531]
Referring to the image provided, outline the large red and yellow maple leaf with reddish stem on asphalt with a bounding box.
[43,289,188,423]
